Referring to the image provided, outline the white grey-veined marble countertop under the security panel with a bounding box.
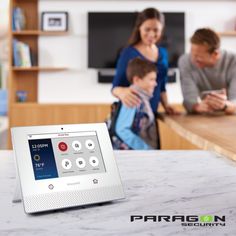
[0,151,236,236]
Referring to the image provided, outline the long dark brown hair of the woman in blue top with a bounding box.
[128,8,165,46]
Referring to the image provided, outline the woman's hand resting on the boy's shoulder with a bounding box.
[112,87,141,107]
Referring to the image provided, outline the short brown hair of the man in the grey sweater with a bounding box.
[190,28,220,54]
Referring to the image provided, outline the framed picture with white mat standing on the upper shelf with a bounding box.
[41,11,68,32]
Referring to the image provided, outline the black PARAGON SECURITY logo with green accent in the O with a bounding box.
[130,215,225,227]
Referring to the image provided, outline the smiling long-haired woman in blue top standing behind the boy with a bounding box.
[112,8,176,114]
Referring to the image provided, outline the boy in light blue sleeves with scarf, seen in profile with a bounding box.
[112,58,159,150]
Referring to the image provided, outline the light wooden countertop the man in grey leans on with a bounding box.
[161,113,236,161]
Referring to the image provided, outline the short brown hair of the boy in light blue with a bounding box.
[126,57,157,84]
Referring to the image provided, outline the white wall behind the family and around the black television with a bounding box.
[39,0,236,103]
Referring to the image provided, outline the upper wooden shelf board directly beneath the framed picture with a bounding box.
[12,30,68,36]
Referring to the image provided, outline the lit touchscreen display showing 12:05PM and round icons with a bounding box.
[28,131,106,180]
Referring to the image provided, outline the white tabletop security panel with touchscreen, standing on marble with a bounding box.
[11,123,124,213]
